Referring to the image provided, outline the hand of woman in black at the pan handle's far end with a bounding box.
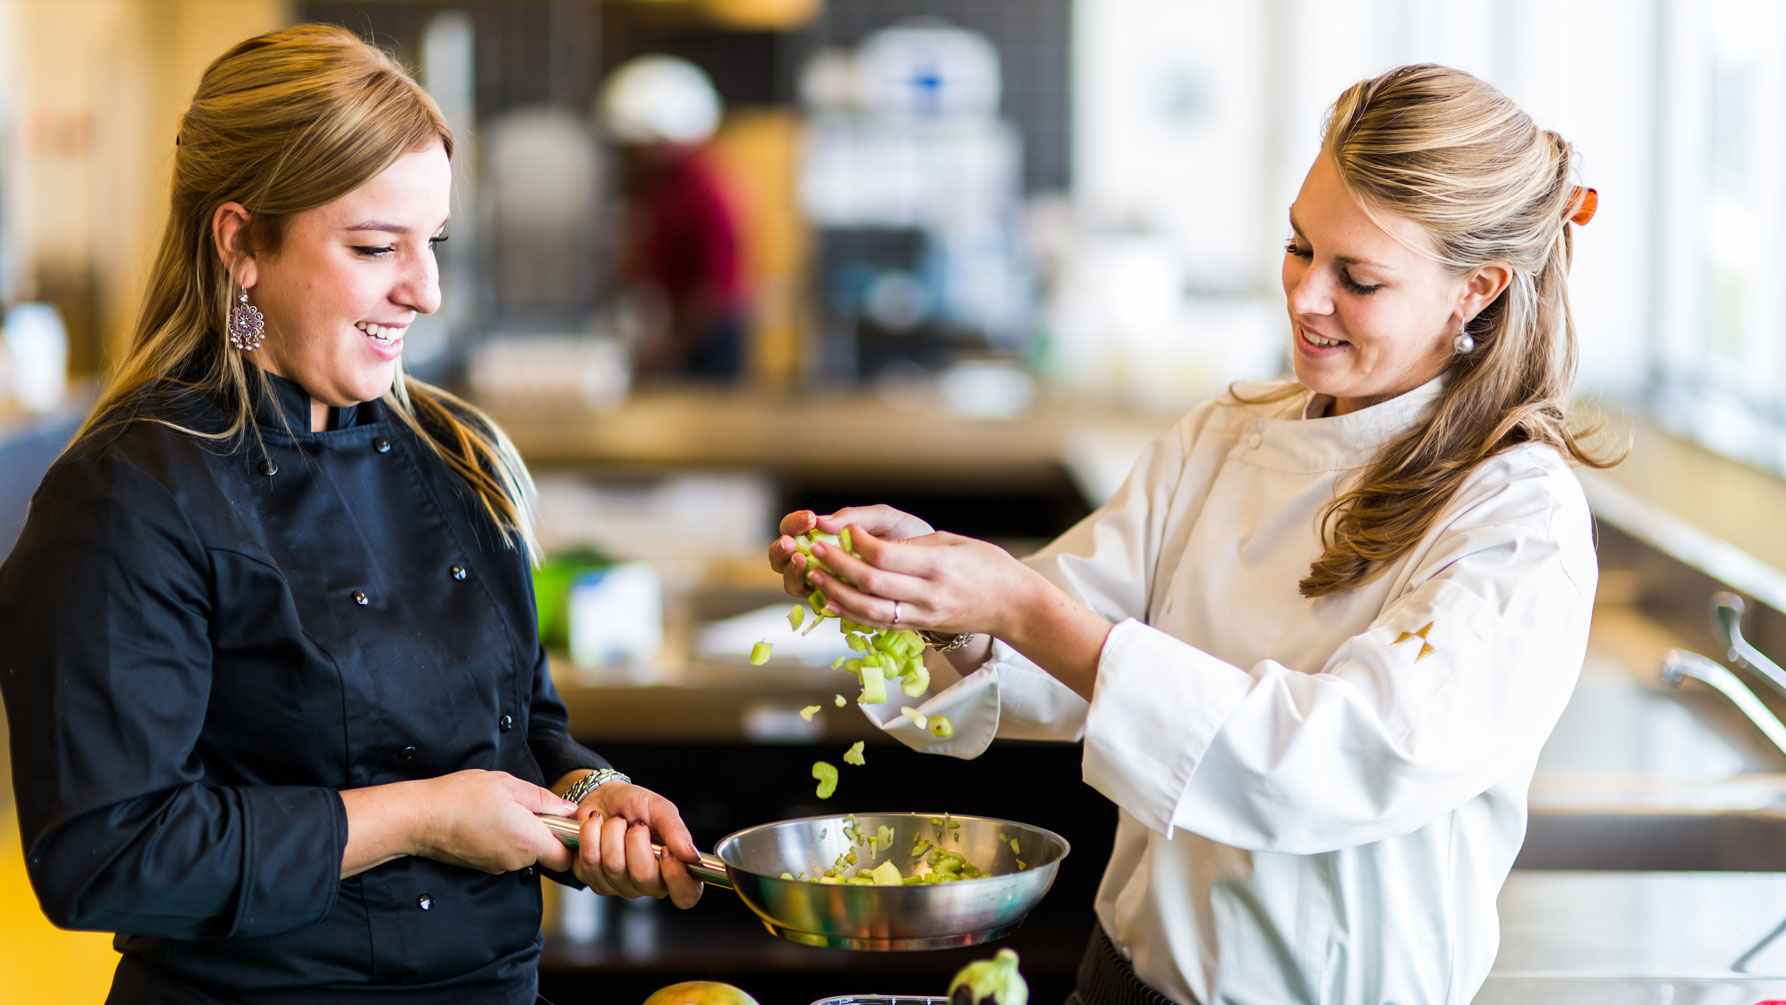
[416,768,577,875]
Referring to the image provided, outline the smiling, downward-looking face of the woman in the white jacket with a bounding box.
[1282,154,1478,414]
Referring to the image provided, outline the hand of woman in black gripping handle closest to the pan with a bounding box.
[573,780,705,909]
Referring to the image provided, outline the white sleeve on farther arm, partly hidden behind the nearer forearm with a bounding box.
[875,407,1207,759]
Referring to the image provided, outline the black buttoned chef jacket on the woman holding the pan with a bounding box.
[0,378,604,1003]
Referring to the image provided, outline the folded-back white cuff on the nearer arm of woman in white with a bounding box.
[1084,619,1252,839]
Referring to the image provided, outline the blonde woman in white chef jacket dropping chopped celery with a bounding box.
[770,66,1607,1005]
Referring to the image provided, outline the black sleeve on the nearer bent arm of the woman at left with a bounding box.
[0,457,346,939]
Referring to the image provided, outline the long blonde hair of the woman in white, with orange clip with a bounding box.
[1271,64,1622,598]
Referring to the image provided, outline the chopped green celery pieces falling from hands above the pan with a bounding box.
[750,527,956,800]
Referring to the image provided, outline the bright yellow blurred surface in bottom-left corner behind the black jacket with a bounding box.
[0,725,118,1005]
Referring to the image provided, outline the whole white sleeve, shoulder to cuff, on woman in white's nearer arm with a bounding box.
[1084,460,1595,855]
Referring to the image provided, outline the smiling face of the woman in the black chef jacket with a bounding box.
[226,145,452,428]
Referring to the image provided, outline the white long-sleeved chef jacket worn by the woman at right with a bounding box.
[882,378,1598,1005]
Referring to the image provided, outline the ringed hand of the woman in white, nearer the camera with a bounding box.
[811,527,1048,639]
